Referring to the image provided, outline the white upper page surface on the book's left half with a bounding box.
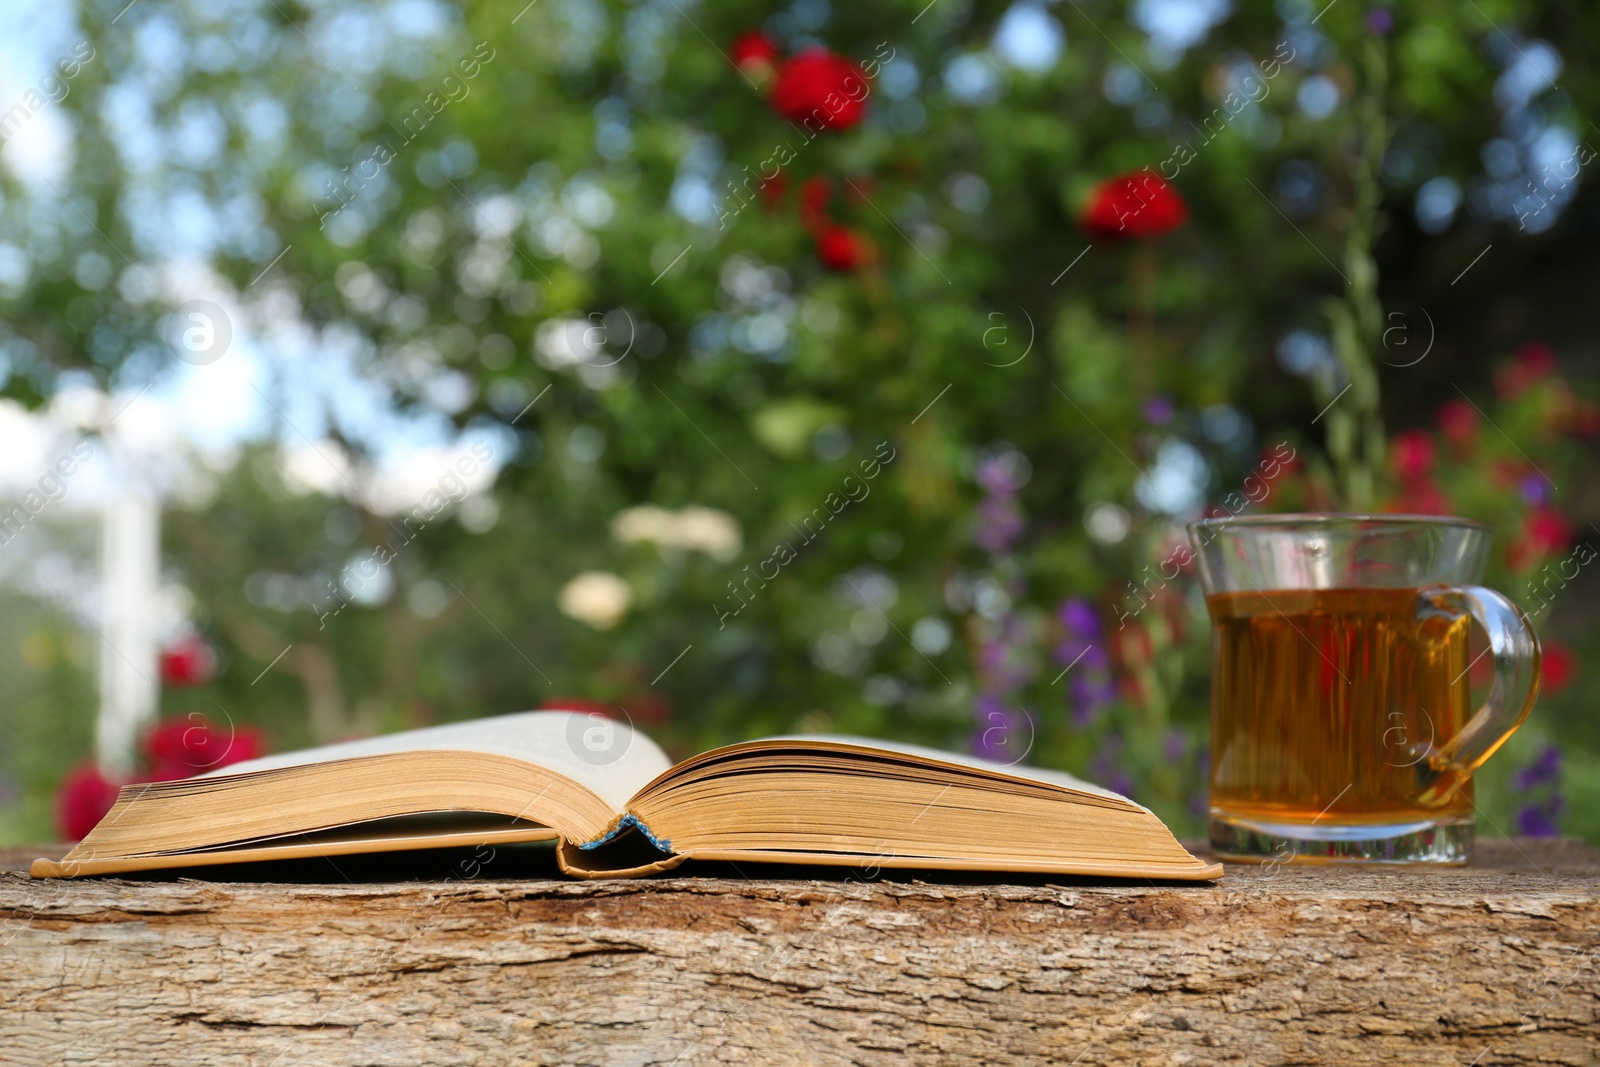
[200,710,672,811]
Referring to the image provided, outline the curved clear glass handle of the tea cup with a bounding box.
[1418,585,1539,803]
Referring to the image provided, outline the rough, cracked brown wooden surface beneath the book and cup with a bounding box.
[0,841,1600,1067]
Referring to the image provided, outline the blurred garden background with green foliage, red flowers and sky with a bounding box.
[0,0,1600,841]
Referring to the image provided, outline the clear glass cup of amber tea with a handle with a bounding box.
[1189,515,1539,864]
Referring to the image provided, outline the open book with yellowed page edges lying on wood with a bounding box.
[30,712,1222,880]
